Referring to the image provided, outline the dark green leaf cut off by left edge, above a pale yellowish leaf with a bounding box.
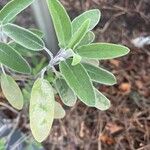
[0,43,30,73]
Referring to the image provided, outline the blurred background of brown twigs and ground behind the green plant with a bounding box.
[0,0,150,150]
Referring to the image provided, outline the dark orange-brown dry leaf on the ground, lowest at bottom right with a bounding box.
[98,134,115,145]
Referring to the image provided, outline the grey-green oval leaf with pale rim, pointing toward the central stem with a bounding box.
[2,23,44,51]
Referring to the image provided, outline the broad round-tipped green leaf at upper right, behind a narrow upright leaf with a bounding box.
[72,9,101,33]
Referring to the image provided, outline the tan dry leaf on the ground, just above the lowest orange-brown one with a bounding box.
[106,122,124,134]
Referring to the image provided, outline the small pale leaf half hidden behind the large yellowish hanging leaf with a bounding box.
[54,101,66,119]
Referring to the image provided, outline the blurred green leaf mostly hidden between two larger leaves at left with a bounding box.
[9,41,35,57]
